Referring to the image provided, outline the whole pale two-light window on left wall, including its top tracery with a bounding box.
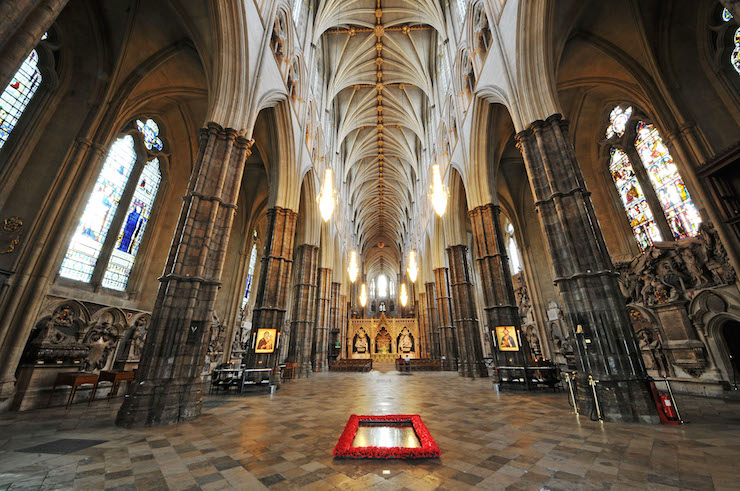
[59,119,164,291]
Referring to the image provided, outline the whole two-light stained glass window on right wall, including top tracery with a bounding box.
[606,106,701,250]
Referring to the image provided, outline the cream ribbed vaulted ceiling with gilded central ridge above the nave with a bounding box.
[314,0,444,273]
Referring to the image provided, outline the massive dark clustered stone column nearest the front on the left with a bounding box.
[116,123,253,427]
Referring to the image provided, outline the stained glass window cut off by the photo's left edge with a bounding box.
[0,50,41,148]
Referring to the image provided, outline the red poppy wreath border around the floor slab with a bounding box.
[334,414,440,459]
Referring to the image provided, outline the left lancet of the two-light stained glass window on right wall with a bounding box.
[609,148,662,246]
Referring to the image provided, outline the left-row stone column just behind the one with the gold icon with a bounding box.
[288,244,319,377]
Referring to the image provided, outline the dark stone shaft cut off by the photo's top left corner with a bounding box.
[0,0,69,88]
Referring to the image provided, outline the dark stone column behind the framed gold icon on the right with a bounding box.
[470,203,529,366]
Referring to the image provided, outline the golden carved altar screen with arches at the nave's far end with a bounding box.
[346,314,421,363]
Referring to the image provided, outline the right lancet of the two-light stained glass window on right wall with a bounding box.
[635,122,701,239]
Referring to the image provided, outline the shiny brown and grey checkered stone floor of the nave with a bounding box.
[0,370,740,490]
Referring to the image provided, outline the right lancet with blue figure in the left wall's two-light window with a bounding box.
[103,158,162,291]
